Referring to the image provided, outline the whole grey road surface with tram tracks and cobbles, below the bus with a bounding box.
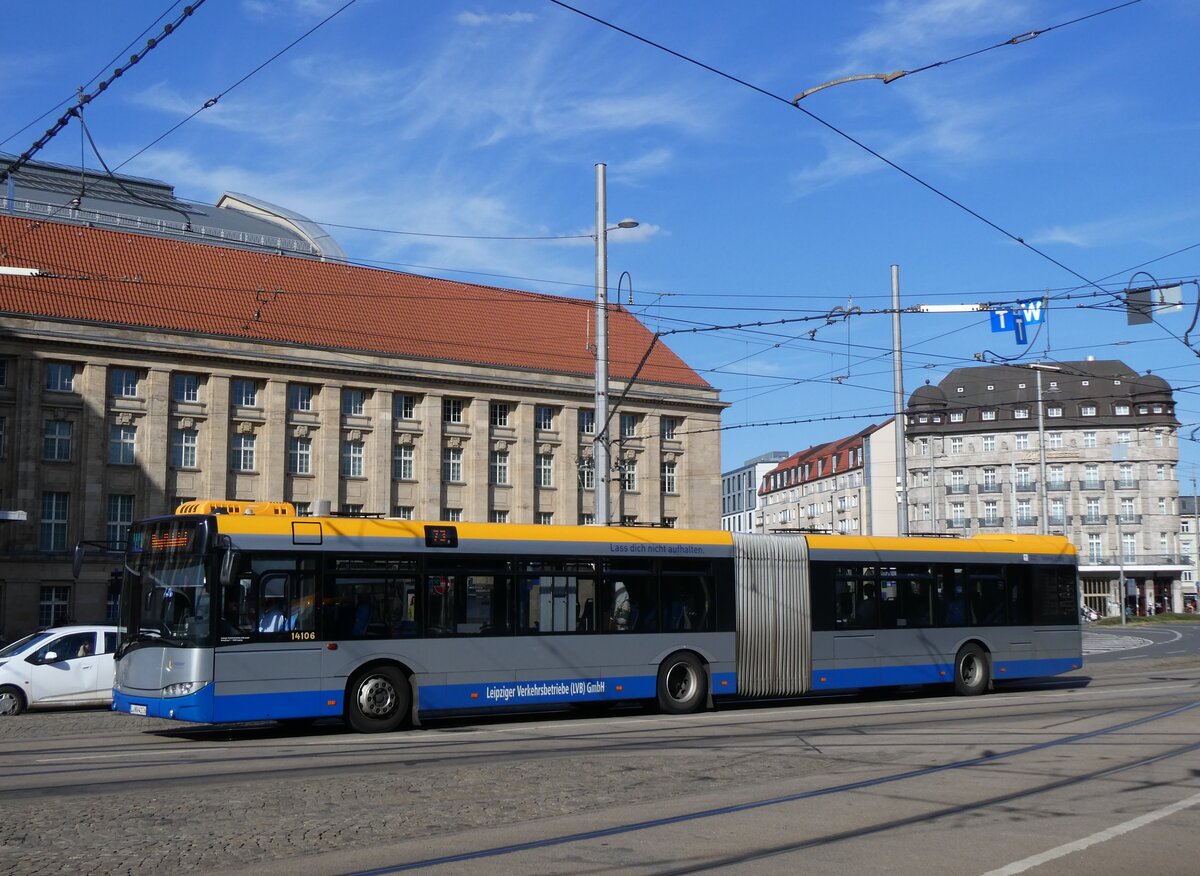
[0,626,1200,876]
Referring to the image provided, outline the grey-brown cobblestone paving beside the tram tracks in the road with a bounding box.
[0,712,833,876]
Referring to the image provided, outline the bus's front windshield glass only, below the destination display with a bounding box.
[120,554,212,646]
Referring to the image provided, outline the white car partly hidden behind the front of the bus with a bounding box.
[0,626,116,715]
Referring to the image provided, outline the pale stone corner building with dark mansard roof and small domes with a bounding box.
[905,359,1190,614]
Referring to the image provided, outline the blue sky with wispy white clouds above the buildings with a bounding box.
[0,0,1200,477]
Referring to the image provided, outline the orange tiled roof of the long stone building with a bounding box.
[0,216,708,388]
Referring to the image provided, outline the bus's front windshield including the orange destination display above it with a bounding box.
[120,511,214,649]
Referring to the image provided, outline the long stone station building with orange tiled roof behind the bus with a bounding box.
[0,158,722,640]
